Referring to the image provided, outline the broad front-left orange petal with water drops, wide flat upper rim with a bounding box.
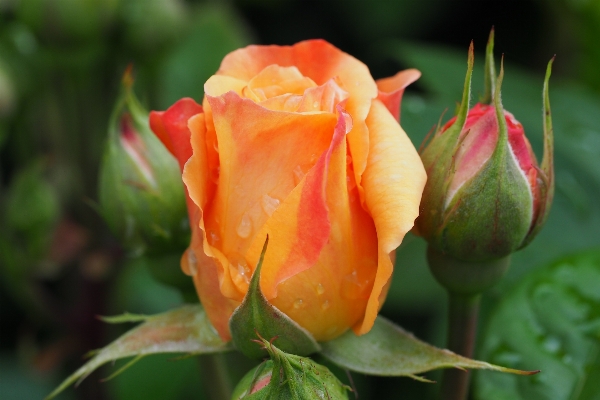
[205,92,336,296]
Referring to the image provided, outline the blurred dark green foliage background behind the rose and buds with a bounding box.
[0,0,600,400]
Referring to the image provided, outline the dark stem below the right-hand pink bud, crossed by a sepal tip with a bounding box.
[442,291,481,400]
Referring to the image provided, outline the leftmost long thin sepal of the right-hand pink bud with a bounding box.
[416,42,475,240]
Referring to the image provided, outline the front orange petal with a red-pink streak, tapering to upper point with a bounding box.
[252,110,377,341]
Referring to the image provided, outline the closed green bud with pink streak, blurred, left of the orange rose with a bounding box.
[99,72,190,255]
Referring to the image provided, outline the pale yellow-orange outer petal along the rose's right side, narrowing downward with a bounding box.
[354,100,427,335]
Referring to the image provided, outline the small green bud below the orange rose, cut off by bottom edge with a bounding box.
[231,338,350,400]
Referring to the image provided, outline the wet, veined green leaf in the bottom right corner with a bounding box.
[476,249,600,400]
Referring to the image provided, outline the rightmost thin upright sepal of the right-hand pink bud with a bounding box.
[521,57,554,247]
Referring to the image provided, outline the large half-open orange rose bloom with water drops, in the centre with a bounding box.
[150,40,426,341]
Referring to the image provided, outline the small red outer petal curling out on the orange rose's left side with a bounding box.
[150,98,202,171]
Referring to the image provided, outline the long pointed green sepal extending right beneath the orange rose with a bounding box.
[321,316,535,382]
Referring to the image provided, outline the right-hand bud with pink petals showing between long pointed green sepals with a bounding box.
[416,45,554,262]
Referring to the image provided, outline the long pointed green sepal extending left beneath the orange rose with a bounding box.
[47,305,231,399]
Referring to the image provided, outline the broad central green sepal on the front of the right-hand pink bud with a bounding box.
[434,64,533,261]
